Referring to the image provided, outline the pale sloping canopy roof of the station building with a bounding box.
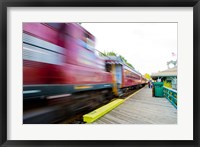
[151,66,177,78]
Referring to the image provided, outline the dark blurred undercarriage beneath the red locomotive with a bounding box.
[23,89,113,124]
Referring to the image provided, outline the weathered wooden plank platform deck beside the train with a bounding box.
[93,86,177,124]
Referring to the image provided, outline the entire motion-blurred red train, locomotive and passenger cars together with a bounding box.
[23,23,146,124]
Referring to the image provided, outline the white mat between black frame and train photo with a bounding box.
[7,7,193,140]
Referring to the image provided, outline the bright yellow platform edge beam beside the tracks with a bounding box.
[83,99,125,123]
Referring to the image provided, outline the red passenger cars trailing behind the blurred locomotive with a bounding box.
[105,56,147,96]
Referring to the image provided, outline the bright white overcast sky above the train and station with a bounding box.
[81,23,177,75]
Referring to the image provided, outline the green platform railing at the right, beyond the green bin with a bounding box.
[163,86,177,108]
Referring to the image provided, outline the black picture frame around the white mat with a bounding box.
[0,0,200,147]
